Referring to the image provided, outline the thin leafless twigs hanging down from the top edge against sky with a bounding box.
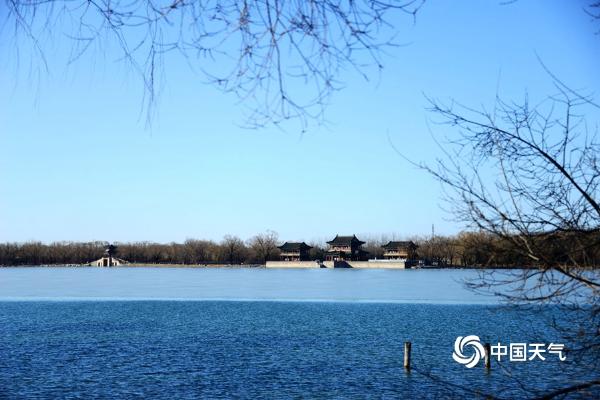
[4,0,424,127]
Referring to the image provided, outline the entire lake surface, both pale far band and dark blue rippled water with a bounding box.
[0,268,597,399]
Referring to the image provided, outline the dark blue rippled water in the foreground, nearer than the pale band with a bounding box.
[0,301,597,399]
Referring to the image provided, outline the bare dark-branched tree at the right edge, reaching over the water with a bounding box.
[420,79,600,397]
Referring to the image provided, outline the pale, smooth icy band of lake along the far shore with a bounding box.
[0,267,495,304]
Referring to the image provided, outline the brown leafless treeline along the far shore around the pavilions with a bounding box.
[0,231,600,267]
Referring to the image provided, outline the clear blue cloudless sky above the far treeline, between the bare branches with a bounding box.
[0,0,600,242]
